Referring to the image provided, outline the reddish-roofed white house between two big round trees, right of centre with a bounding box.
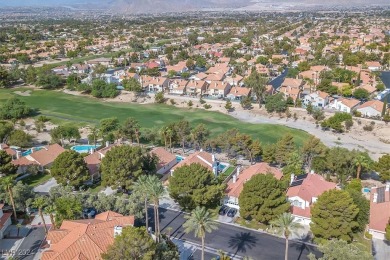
[287,172,336,225]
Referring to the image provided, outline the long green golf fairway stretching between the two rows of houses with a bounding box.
[0,89,309,145]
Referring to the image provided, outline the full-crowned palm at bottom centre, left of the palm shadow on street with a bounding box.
[183,206,218,260]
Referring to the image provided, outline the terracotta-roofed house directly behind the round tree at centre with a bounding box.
[171,151,219,175]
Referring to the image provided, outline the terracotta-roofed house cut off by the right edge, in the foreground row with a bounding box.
[368,183,390,239]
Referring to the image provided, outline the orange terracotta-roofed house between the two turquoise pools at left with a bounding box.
[12,144,65,172]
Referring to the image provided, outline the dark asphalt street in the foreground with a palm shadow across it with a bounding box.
[155,208,319,260]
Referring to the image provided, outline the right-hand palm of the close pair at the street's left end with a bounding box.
[146,175,165,243]
